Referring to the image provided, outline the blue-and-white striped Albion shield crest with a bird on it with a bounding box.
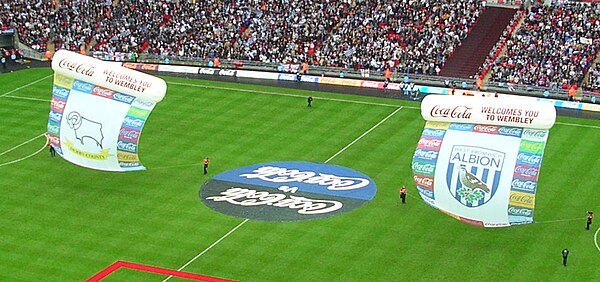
[446,145,505,207]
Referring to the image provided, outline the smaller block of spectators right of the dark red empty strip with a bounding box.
[490,3,600,89]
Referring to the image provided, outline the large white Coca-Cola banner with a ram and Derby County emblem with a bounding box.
[48,50,166,171]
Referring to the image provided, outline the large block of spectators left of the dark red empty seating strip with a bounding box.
[0,0,483,74]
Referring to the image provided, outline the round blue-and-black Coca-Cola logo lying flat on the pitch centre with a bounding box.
[199,162,377,221]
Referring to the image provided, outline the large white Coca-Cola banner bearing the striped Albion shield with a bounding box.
[412,95,556,227]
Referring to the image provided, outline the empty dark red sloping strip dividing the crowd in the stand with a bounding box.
[440,7,517,78]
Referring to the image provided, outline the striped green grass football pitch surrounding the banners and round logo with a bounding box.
[0,69,600,281]
